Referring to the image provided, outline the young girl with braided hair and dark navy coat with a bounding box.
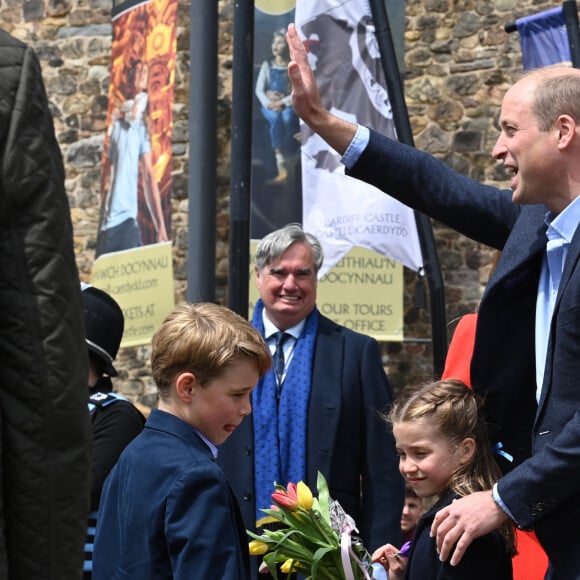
[373,380,515,580]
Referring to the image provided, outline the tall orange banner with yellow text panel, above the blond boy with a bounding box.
[91,0,178,346]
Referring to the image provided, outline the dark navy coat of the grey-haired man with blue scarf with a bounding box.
[218,315,404,568]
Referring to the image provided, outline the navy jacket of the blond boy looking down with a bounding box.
[93,409,249,580]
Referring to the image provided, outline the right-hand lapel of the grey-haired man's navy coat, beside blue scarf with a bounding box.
[307,315,345,489]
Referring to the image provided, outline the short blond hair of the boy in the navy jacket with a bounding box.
[151,302,272,400]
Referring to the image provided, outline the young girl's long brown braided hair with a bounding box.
[386,379,516,554]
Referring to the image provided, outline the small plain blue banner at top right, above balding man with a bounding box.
[516,6,571,70]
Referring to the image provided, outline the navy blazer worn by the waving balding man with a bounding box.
[348,131,580,580]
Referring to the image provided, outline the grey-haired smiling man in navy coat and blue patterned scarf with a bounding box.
[218,224,404,572]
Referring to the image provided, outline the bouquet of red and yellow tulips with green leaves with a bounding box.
[248,472,372,580]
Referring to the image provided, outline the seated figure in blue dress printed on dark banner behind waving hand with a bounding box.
[255,30,300,183]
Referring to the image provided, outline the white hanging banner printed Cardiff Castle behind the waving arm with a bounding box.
[296,0,423,276]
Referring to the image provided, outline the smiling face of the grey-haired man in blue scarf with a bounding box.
[256,242,317,330]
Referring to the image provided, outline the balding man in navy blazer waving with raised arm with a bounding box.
[288,20,580,580]
